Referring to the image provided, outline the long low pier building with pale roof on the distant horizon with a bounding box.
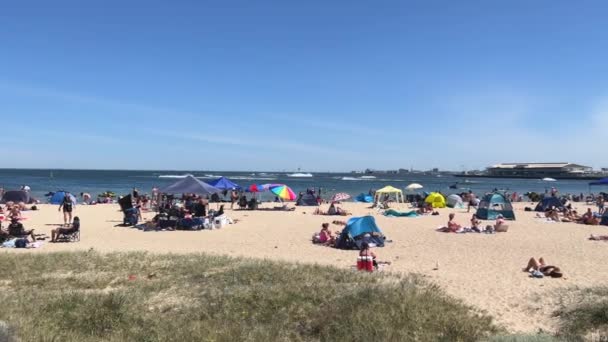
[487,163,593,178]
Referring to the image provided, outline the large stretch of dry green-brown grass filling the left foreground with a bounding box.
[0,252,501,341]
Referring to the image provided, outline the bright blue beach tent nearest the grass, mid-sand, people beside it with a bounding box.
[336,216,384,249]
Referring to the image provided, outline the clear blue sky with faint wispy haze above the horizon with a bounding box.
[0,0,608,171]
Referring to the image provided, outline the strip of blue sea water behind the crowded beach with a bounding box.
[0,169,604,200]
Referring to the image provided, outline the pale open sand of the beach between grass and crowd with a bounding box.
[0,203,608,332]
